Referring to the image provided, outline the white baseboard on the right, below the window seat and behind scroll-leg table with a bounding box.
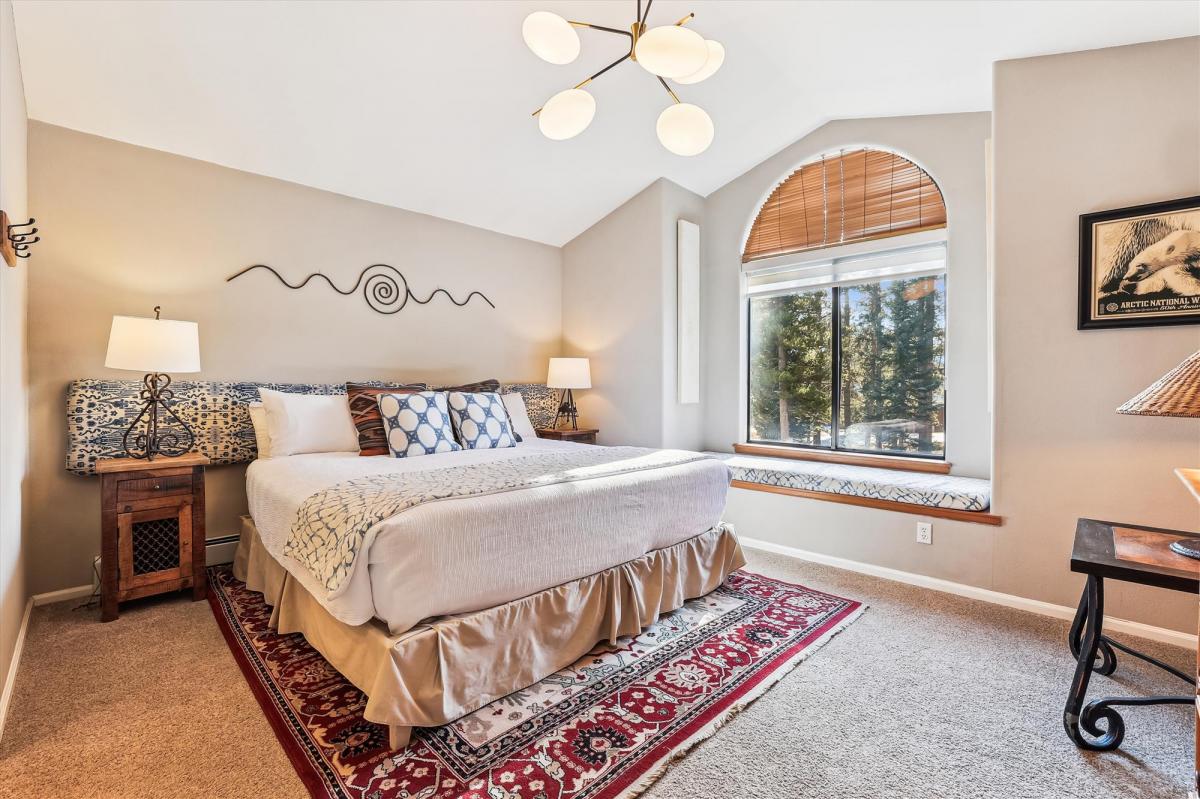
[738,535,1196,650]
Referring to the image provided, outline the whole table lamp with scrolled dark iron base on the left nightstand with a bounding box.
[104,306,200,461]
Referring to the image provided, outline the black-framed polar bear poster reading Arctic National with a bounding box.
[1079,197,1200,330]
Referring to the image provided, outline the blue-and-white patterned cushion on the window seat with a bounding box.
[708,452,991,511]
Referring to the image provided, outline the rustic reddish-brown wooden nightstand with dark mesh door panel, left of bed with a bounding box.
[96,452,209,621]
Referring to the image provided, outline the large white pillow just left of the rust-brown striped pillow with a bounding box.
[258,389,359,457]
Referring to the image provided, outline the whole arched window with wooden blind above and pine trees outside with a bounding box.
[743,149,946,458]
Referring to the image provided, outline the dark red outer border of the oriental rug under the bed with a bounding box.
[208,566,869,799]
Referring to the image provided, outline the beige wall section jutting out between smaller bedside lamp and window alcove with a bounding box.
[563,179,704,449]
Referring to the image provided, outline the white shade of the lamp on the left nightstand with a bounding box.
[104,317,200,373]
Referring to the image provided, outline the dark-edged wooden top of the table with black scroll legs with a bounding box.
[1070,518,1200,594]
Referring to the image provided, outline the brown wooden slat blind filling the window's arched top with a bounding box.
[742,149,946,263]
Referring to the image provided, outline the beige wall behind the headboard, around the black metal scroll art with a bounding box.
[29,122,562,591]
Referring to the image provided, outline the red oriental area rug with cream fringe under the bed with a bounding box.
[209,567,863,799]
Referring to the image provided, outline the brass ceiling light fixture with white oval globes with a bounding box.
[521,0,725,156]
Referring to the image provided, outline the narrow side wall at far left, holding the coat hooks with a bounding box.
[0,0,30,705]
